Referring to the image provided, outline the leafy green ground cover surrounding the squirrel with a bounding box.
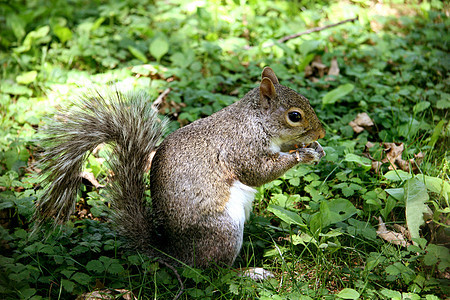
[0,0,450,300]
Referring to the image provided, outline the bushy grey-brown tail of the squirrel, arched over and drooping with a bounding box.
[37,91,166,245]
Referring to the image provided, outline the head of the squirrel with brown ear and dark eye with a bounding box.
[259,67,325,152]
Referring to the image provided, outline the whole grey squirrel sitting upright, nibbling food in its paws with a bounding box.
[37,67,325,267]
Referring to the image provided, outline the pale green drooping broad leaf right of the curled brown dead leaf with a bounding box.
[405,178,429,238]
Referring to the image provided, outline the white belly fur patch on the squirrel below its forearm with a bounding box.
[226,180,256,257]
